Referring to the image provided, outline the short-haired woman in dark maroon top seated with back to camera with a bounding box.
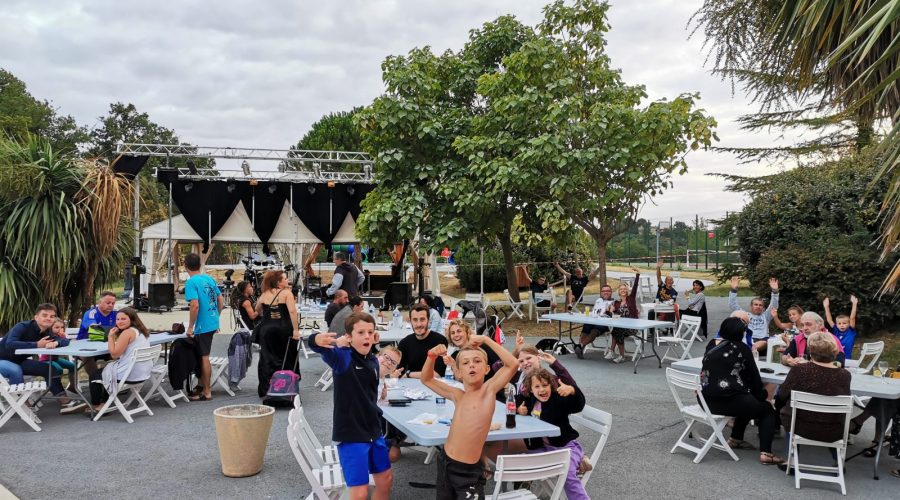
[775,332,850,464]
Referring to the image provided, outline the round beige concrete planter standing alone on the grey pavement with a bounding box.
[213,405,275,477]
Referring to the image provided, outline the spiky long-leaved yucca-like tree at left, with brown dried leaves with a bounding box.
[0,136,132,330]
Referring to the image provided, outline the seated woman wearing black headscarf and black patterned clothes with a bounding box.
[700,318,784,465]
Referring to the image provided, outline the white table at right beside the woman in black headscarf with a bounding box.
[672,357,900,479]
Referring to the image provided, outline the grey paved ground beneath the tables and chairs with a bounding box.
[0,299,900,500]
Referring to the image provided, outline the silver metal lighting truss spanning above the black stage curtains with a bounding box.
[116,143,375,183]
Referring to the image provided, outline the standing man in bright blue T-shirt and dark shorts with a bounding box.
[184,253,225,401]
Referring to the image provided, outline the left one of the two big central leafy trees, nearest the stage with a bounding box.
[356,16,533,296]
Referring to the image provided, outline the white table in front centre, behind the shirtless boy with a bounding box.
[382,379,559,446]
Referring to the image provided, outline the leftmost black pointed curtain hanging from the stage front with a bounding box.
[172,179,249,253]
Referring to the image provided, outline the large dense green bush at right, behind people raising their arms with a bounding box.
[722,148,900,328]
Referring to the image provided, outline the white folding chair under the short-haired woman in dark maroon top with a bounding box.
[787,391,853,495]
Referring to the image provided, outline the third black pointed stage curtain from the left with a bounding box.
[292,183,350,244]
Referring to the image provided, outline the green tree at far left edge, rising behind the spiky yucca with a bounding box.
[0,68,89,152]
